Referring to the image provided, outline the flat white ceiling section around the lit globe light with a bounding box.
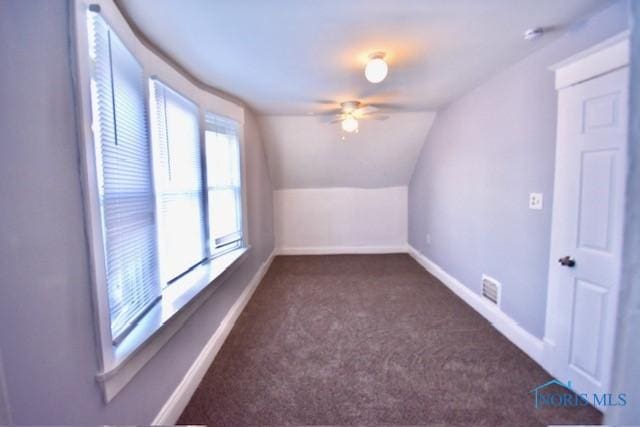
[121,0,609,115]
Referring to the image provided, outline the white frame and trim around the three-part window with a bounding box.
[71,0,251,403]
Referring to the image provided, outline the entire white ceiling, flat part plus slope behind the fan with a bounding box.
[116,0,610,188]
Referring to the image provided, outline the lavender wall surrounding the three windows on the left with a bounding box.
[0,0,273,424]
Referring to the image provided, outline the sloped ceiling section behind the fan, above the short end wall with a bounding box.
[260,112,435,189]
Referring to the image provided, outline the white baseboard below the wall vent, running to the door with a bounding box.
[409,245,546,369]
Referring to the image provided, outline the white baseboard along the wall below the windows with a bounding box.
[152,250,275,425]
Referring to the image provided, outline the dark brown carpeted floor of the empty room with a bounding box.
[178,254,601,426]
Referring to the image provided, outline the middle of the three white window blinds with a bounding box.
[150,80,207,285]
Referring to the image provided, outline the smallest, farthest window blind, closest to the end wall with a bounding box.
[205,113,242,251]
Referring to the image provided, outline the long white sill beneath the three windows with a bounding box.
[96,247,250,402]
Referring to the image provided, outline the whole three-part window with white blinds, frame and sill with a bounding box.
[79,5,247,401]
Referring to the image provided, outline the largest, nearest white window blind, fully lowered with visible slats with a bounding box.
[88,13,161,343]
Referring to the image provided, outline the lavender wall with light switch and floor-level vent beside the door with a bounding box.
[409,1,628,337]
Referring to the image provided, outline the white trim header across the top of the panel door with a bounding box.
[549,30,631,89]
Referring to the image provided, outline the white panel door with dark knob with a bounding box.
[545,67,628,393]
